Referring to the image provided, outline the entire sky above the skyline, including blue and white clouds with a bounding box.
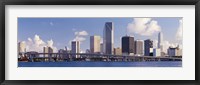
[18,17,183,52]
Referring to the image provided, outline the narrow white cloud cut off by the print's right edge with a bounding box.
[176,19,183,42]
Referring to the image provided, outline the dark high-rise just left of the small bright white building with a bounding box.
[144,39,153,56]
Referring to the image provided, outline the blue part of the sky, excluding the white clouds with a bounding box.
[18,17,182,51]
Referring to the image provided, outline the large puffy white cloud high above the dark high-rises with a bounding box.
[127,18,161,36]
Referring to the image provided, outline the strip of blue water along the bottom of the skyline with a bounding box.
[18,61,182,67]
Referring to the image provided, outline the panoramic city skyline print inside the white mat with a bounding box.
[18,17,182,67]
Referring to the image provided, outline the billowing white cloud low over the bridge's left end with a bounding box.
[25,35,57,52]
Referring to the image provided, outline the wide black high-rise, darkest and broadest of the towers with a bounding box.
[122,36,134,55]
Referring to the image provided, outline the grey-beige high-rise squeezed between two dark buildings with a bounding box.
[135,40,144,55]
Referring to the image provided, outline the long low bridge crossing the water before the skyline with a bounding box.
[21,52,182,62]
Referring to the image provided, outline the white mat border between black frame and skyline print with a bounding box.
[5,5,195,80]
